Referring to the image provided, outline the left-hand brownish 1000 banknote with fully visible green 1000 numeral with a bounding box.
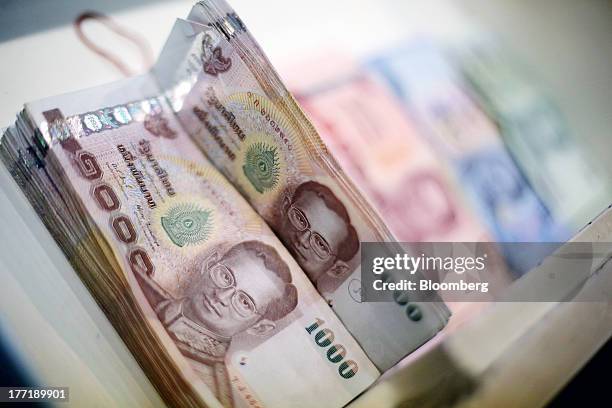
[4,75,379,407]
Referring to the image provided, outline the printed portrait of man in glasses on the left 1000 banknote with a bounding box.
[134,240,298,406]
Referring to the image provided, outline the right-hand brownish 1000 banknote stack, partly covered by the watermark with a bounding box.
[148,1,448,370]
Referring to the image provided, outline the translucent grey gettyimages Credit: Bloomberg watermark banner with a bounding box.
[360,242,612,302]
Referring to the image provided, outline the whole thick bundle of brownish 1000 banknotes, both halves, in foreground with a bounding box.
[0,0,449,407]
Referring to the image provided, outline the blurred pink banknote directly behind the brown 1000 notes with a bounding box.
[282,57,490,242]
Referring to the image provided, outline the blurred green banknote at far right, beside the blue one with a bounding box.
[455,41,612,232]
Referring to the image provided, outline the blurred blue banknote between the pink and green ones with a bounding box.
[366,41,569,274]
